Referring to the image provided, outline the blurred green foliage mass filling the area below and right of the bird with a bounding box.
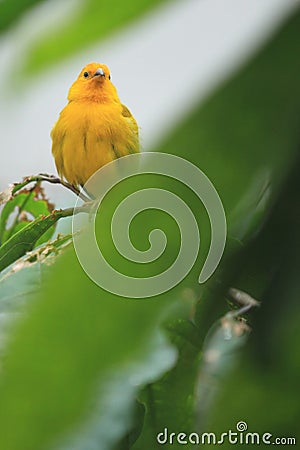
[0,3,300,450]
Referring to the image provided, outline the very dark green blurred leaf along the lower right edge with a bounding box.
[206,158,300,449]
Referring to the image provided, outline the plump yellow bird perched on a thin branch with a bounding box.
[51,63,139,187]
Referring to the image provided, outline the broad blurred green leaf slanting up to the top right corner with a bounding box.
[158,9,300,238]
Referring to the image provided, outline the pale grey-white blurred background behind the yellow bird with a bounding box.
[0,0,299,206]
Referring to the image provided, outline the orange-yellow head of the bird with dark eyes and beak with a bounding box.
[68,63,119,103]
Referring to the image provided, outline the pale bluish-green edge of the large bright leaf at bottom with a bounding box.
[55,329,176,450]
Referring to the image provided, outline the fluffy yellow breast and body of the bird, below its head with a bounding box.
[51,101,139,186]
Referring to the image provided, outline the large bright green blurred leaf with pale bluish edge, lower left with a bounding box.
[0,246,175,450]
